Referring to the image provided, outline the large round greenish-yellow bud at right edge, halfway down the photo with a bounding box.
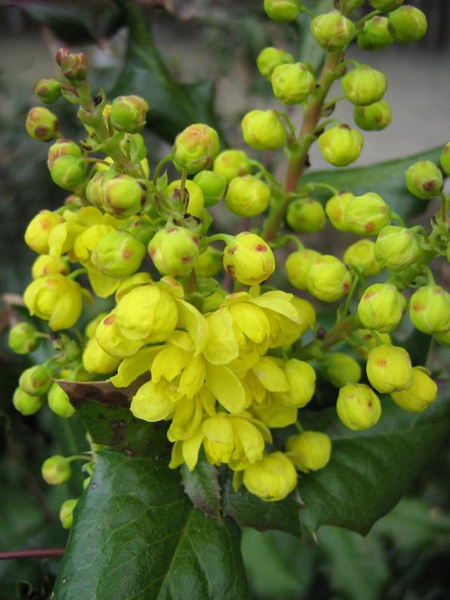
[409,285,450,335]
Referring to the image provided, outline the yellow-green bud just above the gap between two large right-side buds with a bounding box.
[375,225,421,271]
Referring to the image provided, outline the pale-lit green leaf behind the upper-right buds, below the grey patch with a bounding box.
[301,148,442,218]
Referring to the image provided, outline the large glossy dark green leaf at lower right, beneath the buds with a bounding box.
[299,388,450,535]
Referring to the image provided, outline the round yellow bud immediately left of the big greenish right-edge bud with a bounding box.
[358,283,406,333]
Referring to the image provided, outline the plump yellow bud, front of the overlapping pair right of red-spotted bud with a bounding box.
[306,254,352,302]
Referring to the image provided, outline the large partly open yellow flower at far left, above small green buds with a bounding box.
[23,275,83,331]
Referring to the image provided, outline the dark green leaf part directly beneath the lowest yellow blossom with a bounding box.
[222,477,302,538]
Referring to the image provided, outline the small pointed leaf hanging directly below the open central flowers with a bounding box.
[181,453,220,519]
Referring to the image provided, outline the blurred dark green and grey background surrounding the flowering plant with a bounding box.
[0,0,450,600]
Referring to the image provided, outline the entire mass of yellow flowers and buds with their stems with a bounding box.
[9,0,450,528]
